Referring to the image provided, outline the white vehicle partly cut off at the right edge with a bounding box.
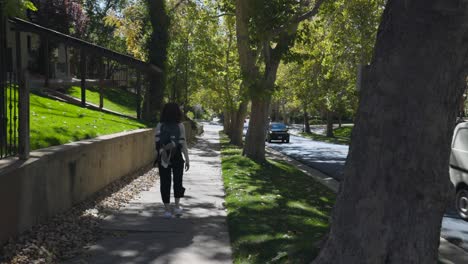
[449,122,468,221]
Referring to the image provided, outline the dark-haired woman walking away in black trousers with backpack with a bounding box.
[156,103,190,218]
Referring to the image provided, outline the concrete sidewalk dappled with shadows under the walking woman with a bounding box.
[69,125,232,264]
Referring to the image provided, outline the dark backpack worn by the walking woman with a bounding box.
[156,123,183,167]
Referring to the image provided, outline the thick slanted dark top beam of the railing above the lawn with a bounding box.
[9,18,162,74]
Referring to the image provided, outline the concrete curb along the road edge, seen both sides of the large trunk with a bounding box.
[267,148,468,264]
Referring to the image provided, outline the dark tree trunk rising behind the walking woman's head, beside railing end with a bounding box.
[143,0,170,122]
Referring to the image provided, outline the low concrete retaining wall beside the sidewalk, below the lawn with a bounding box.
[0,129,155,244]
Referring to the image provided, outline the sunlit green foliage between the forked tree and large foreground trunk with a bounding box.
[278,0,384,121]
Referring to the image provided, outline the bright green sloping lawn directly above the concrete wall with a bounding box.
[30,94,146,149]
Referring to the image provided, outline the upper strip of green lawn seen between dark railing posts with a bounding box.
[67,86,137,117]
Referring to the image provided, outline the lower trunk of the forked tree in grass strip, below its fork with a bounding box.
[244,98,270,162]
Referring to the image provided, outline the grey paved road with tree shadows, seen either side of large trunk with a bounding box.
[267,135,468,252]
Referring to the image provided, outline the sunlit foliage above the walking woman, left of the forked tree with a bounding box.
[168,1,243,116]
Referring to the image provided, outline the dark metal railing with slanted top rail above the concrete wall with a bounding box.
[0,14,161,160]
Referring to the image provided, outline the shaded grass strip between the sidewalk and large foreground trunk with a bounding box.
[221,135,335,264]
